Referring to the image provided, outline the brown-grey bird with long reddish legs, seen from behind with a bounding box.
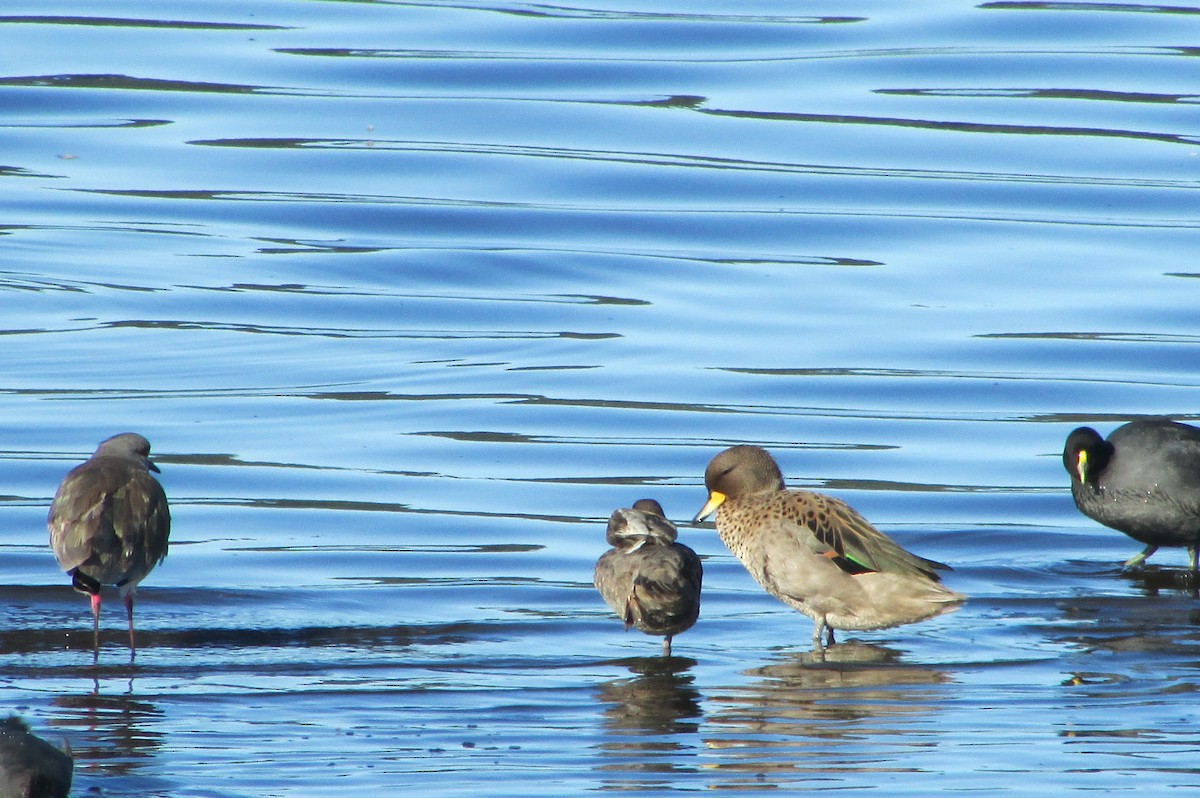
[47,432,170,659]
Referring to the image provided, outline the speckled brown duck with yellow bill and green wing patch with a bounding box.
[692,446,966,649]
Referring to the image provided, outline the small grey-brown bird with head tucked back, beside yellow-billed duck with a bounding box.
[594,499,704,656]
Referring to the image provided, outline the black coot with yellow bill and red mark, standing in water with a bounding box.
[1062,419,1200,571]
